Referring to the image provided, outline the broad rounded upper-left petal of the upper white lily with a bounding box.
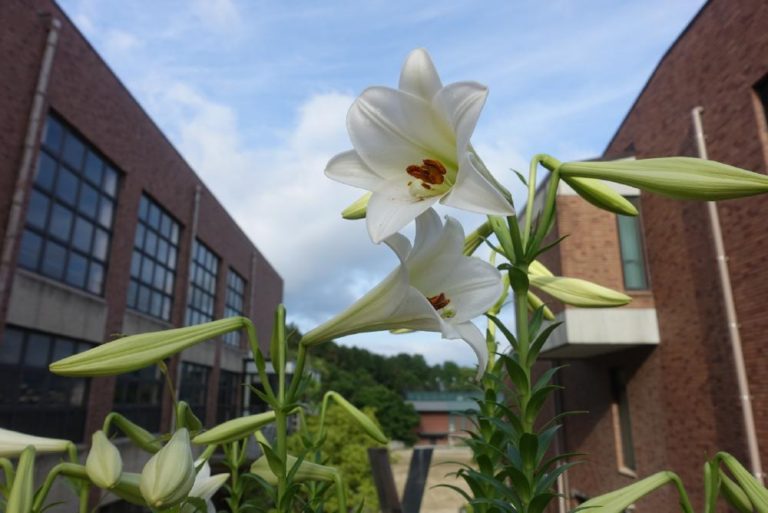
[347,87,456,178]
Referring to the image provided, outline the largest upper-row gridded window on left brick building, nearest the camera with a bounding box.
[19,114,119,295]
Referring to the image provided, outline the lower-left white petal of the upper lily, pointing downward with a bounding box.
[365,180,440,244]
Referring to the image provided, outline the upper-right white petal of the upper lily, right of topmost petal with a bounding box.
[432,82,488,155]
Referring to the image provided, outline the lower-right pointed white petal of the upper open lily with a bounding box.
[440,153,515,216]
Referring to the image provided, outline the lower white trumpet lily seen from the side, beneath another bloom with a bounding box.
[302,209,503,372]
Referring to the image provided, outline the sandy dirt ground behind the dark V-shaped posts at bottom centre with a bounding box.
[391,446,472,513]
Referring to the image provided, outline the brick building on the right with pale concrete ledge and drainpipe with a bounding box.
[546,0,768,512]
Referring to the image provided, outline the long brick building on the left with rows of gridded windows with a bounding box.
[0,0,282,504]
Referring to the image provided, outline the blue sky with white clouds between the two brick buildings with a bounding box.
[59,0,704,365]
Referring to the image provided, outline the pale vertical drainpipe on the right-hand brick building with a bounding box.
[691,106,763,483]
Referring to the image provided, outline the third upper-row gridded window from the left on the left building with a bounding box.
[186,240,219,326]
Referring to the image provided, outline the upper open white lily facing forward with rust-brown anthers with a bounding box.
[325,49,514,243]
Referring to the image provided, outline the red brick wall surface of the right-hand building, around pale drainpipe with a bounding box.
[562,0,768,512]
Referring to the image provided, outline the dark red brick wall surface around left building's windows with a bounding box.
[0,0,283,440]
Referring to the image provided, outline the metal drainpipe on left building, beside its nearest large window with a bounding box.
[0,17,61,310]
